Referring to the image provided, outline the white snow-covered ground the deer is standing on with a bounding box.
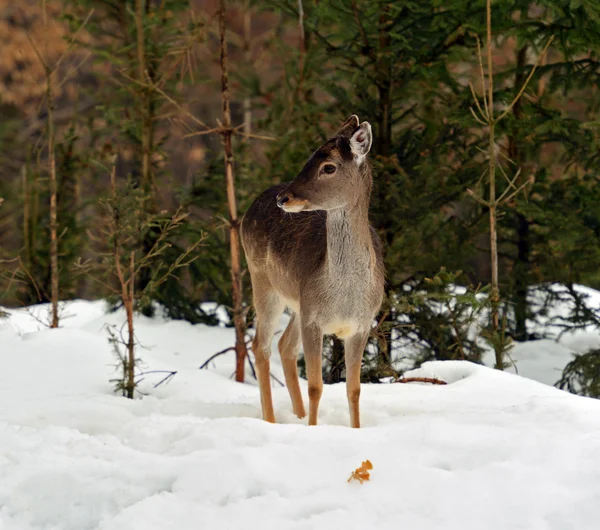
[0,301,600,530]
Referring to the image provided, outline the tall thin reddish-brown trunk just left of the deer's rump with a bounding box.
[219,0,248,383]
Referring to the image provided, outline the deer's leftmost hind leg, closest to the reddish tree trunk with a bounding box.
[252,276,284,423]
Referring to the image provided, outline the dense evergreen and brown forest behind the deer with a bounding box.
[0,0,600,397]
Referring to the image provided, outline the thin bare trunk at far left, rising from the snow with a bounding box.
[46,72,59,328]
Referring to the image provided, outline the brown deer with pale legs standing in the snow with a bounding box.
[242,115,384,427]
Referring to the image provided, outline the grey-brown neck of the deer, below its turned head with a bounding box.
[327,197,373,276]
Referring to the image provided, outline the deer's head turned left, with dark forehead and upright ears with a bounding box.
[277,115,373,212]
